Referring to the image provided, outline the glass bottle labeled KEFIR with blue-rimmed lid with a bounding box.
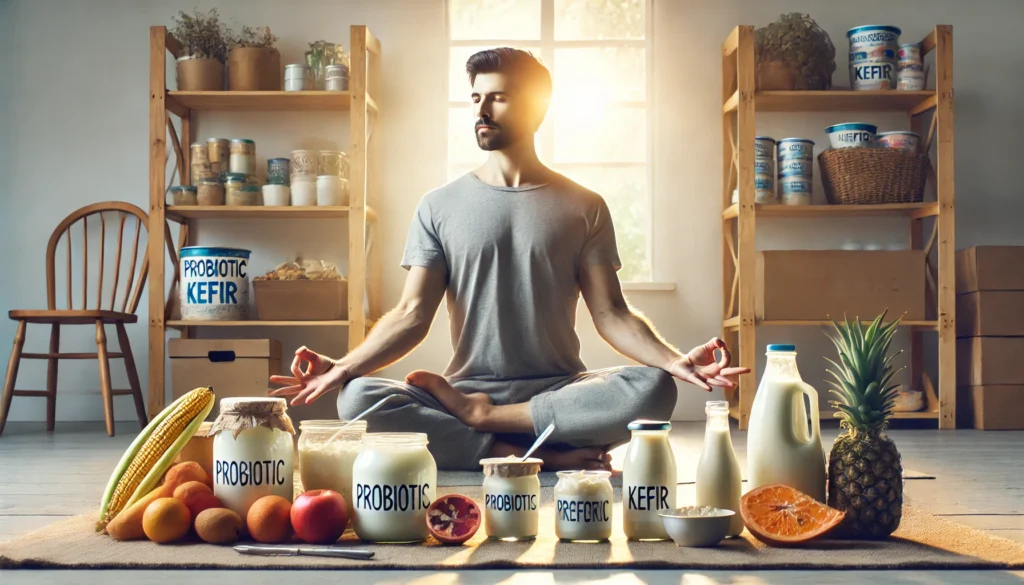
[623,420,677,540]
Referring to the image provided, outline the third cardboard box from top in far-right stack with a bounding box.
[956,337,1024,386]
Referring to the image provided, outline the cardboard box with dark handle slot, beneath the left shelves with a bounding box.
[167,338,281,420]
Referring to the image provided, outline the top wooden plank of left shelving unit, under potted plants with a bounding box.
[167,91,351,112]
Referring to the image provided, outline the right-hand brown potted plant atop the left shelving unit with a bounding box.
[227,27,281,91]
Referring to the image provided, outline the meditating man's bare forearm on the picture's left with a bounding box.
[338,307,430,377]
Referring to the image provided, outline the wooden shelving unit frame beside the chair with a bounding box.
[148,26,381,417]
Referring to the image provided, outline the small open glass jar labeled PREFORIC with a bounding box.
[555,471,614,542]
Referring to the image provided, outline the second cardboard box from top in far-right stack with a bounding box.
[956,291,1024,337]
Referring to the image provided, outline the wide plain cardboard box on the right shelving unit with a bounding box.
[757,250,926,321]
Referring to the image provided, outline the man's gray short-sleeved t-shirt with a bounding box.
[401,173,622,379]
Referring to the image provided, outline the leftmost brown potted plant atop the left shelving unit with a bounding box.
[171,8,227,91]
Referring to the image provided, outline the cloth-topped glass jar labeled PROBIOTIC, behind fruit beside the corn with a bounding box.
[211,398,295,518]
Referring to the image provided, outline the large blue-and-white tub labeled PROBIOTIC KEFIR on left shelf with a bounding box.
[179,246,251,321]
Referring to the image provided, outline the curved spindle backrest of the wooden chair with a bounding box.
[46,201,150,314]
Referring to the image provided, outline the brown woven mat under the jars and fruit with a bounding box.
[0,490,1011,570]
